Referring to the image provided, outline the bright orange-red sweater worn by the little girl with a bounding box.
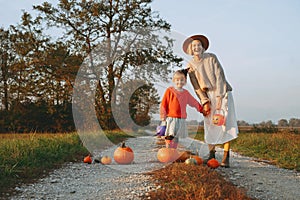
[160,87,203,119]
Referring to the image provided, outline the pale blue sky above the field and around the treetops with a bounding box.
[0,0,300,123]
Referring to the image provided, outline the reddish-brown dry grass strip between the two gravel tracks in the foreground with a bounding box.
[147,163,251,200]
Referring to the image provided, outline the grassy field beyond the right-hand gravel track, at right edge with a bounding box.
[232,132,300,171]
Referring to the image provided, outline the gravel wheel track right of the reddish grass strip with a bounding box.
[220,149,300,200]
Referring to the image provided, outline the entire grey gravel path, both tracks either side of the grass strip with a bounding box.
[10,136,300,200]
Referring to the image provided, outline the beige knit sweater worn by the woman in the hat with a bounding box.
[187,53,232,105]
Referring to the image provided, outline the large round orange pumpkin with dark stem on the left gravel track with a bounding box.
[114,142,134,164]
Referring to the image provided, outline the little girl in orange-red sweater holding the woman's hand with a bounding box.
[160,69,202,148]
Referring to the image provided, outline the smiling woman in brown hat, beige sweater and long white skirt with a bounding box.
[183,35,238,167]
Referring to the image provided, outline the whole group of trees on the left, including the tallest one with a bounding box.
[0,0,182,132]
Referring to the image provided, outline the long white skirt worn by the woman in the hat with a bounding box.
[204,91,239,144]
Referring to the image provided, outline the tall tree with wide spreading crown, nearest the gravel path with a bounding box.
[34,0,181,129]
